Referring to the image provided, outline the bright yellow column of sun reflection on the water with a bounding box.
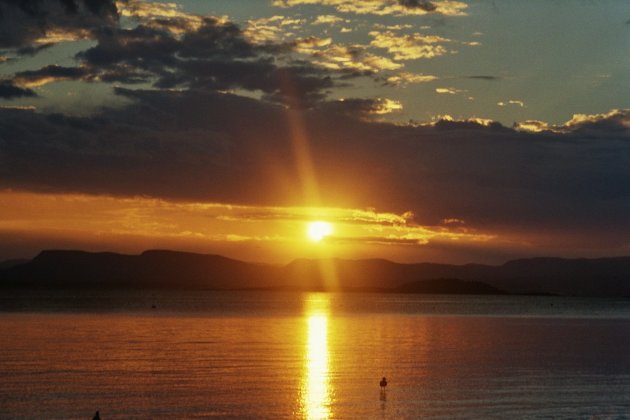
[301,294,332,419]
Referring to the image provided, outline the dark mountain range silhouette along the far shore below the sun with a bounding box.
[0,250,630,296]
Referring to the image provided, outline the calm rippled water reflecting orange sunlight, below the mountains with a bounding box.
[0,292,630,420]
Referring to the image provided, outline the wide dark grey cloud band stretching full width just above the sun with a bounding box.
[0,89,630,249]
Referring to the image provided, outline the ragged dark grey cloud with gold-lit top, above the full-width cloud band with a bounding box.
[77,18,334,108]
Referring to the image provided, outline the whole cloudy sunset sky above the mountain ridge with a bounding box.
[0,0,630,263]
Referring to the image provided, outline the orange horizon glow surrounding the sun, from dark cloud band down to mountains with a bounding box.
[0,190,493,269]
